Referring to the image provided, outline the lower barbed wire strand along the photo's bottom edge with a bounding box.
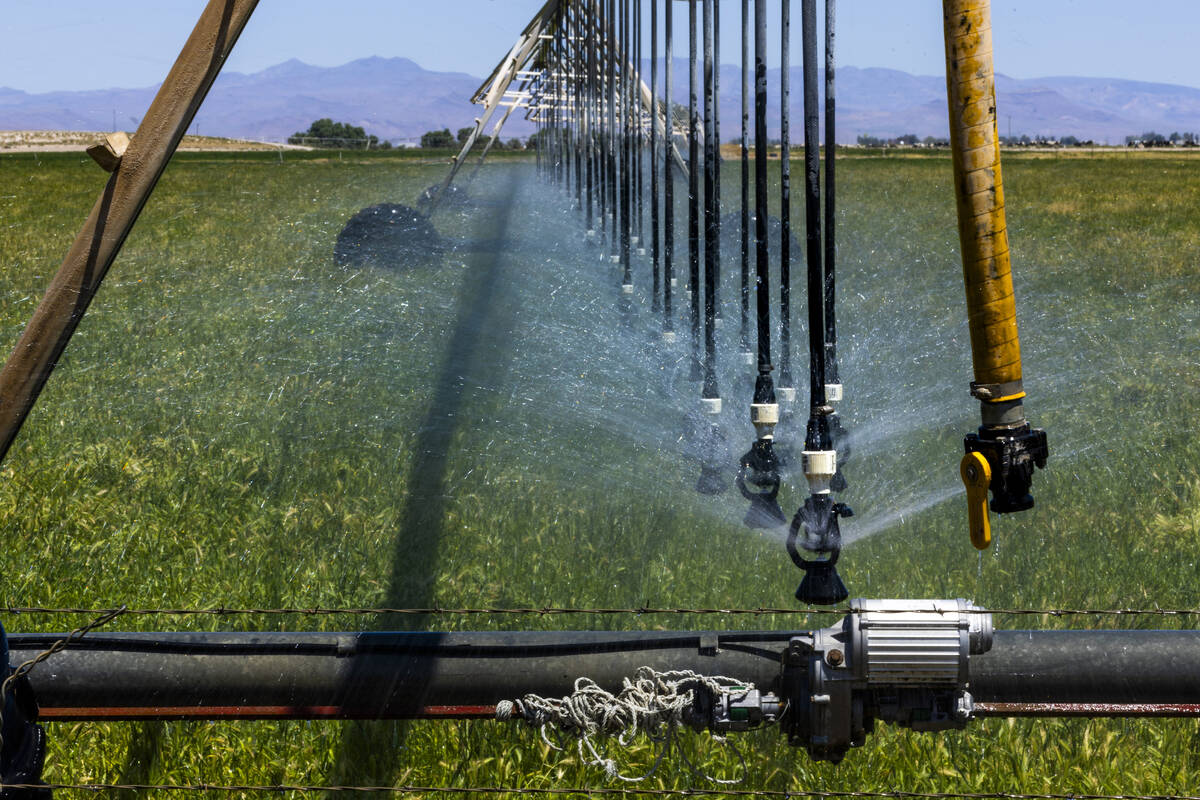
[0,783,1200,800]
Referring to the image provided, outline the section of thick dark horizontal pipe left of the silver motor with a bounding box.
[10,632,790,718]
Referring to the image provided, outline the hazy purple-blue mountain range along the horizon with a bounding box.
[0,58,1200,144]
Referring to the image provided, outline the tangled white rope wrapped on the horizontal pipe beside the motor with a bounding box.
[496,667,752,784]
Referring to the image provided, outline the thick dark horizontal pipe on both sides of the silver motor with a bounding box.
[10,631,1200,721]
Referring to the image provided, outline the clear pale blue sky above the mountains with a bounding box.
[0,0,1200,92]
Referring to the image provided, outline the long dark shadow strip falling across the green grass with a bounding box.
[331,173,517,786]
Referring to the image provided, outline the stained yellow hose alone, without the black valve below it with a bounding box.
[942,0,1025,404]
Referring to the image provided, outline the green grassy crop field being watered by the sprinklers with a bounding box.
[0,148,1200,794]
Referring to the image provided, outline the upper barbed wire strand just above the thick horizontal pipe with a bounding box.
[0,606,1200,616]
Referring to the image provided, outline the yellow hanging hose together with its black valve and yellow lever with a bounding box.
[943,0,1049,549]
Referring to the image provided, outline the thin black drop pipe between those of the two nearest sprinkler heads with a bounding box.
[779,0,796,390]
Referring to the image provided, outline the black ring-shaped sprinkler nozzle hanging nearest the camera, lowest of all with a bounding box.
[787,494,854,606]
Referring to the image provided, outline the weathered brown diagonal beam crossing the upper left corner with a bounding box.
[0,0,258,461]
